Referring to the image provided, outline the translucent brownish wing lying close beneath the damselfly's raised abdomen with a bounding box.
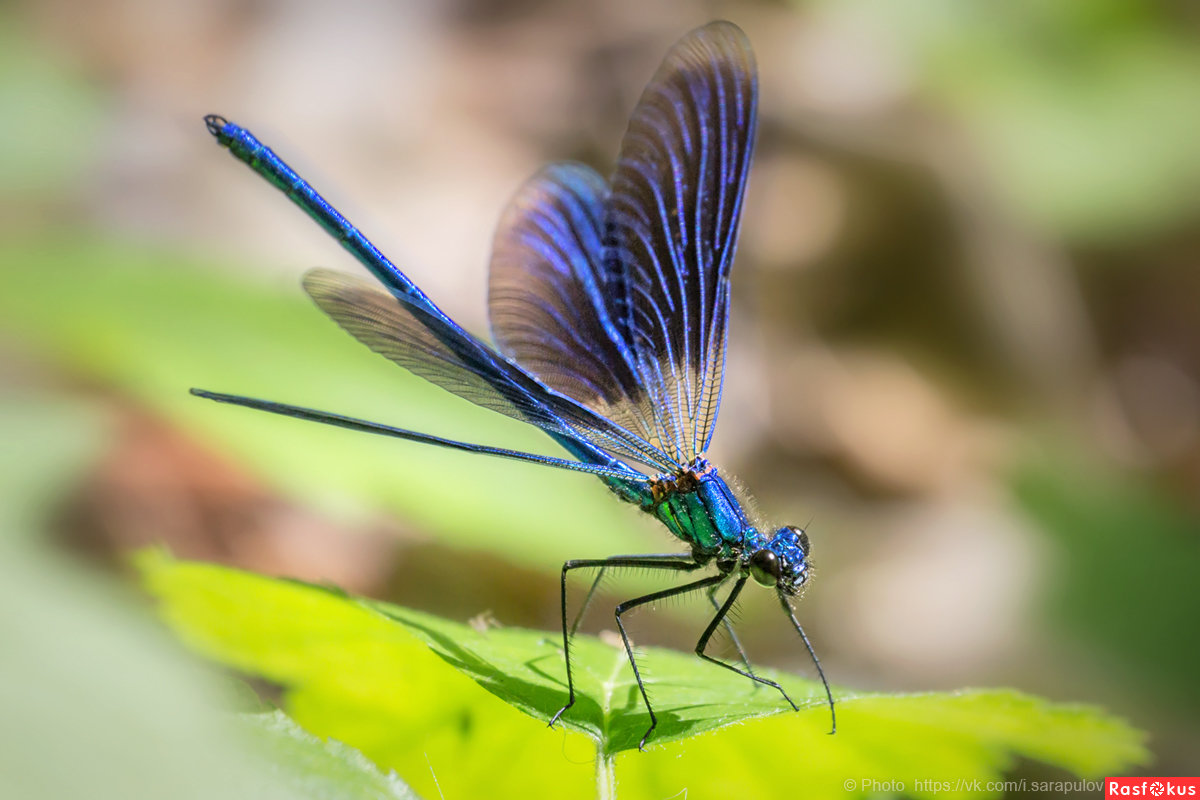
[304,270,668,476]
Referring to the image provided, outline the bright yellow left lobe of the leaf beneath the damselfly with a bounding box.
[138,552,593,798]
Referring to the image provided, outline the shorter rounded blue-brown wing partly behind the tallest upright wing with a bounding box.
[487,163,655,450]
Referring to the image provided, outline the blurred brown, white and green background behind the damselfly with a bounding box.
[0,0,1200,791]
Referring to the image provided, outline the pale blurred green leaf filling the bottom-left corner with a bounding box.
[0,531,415,800]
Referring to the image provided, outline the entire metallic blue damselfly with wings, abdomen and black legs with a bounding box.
[192,22,836,747]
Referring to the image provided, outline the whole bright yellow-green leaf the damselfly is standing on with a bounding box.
[139,552,1145,798]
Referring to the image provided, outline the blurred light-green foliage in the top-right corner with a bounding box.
[830,0,1200,242]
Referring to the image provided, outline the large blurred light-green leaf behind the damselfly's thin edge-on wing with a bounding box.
[0,235,653,569]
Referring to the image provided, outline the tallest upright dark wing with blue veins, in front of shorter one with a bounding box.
[602,23,757,463]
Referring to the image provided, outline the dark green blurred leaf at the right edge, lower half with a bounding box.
[1013,455,1200,710]
